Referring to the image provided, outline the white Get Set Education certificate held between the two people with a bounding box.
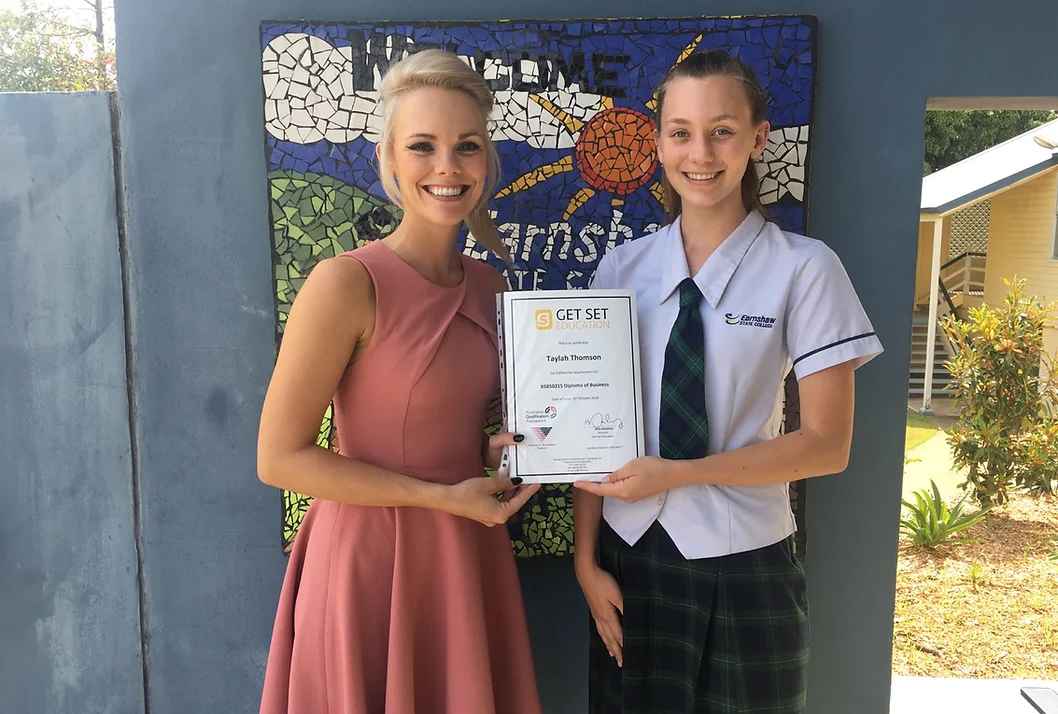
[496,290,644,483]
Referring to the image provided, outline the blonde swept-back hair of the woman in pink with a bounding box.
[379,50,510,262]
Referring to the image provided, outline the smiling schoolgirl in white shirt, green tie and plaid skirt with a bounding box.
[574,51,882,714]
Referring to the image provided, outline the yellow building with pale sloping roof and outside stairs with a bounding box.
[909,121,1058,411]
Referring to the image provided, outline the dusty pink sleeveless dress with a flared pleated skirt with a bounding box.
[260,241,541,714]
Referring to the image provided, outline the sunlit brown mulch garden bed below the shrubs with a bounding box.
[893,494,1058,679]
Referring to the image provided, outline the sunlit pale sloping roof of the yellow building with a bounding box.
[920,120,1058,214]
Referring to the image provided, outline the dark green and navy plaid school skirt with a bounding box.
[589,521,808,714]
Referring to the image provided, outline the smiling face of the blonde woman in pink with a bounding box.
[379,87,489,227]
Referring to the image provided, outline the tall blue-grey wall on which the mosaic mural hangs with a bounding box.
[109,0,1058,714]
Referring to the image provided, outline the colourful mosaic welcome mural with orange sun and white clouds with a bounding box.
[261,17,816,555]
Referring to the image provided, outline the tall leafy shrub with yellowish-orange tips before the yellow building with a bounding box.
[942,279,1058,507]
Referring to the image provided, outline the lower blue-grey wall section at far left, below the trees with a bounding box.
[0,94,143,714]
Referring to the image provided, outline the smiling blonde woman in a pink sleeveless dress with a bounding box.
[257,50,541,714]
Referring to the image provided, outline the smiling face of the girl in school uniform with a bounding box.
[657,75,770,217]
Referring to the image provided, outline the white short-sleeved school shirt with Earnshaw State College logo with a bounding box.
[591,212,882,559]
